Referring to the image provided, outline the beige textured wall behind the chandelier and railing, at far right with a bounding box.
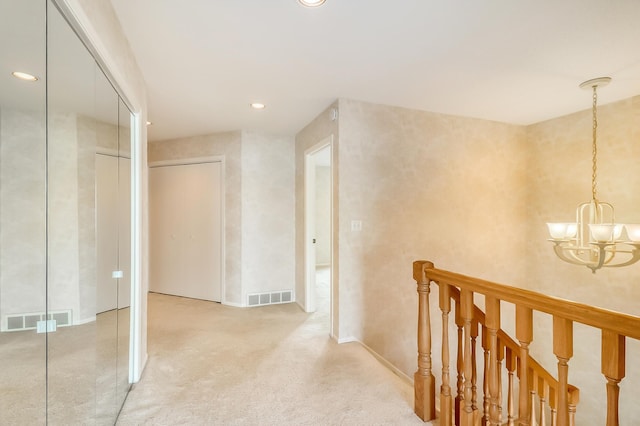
[525,95,640,424]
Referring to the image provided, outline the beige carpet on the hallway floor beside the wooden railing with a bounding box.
[118,280,423,425]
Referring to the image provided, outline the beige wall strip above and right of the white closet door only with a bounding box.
[148,132,242,304]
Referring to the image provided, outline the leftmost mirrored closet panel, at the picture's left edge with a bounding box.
[0,0,46,425]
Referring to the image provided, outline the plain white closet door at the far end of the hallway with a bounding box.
[149,162,223,302]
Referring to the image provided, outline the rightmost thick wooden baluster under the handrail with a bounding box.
[602,330,626,426]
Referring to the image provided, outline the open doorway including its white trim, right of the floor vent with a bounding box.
[304,136,335,336]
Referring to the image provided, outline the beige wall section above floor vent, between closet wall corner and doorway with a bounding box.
[242,131,295,303]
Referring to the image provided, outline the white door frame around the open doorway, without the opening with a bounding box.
[304,135,337,336]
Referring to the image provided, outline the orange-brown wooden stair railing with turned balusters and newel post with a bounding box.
[413,261,640,426]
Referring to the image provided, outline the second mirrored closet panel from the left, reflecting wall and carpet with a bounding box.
[47,3,101,424]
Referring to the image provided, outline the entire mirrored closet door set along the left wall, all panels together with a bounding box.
[0,0,131,425]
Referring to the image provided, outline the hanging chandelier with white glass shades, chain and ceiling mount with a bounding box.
[547,77,640,273]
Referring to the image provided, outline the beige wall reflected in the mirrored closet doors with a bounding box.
[0,109,118,326]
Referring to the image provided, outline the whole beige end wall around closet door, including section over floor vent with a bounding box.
[149,131,295,305]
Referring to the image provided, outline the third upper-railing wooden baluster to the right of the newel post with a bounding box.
[485,296,500,426]
